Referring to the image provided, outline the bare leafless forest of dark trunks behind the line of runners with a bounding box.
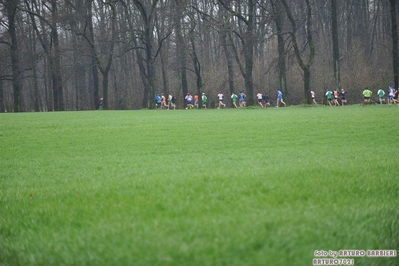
[0,0,399,112]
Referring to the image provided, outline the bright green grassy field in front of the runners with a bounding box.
[0,105,399,265]
